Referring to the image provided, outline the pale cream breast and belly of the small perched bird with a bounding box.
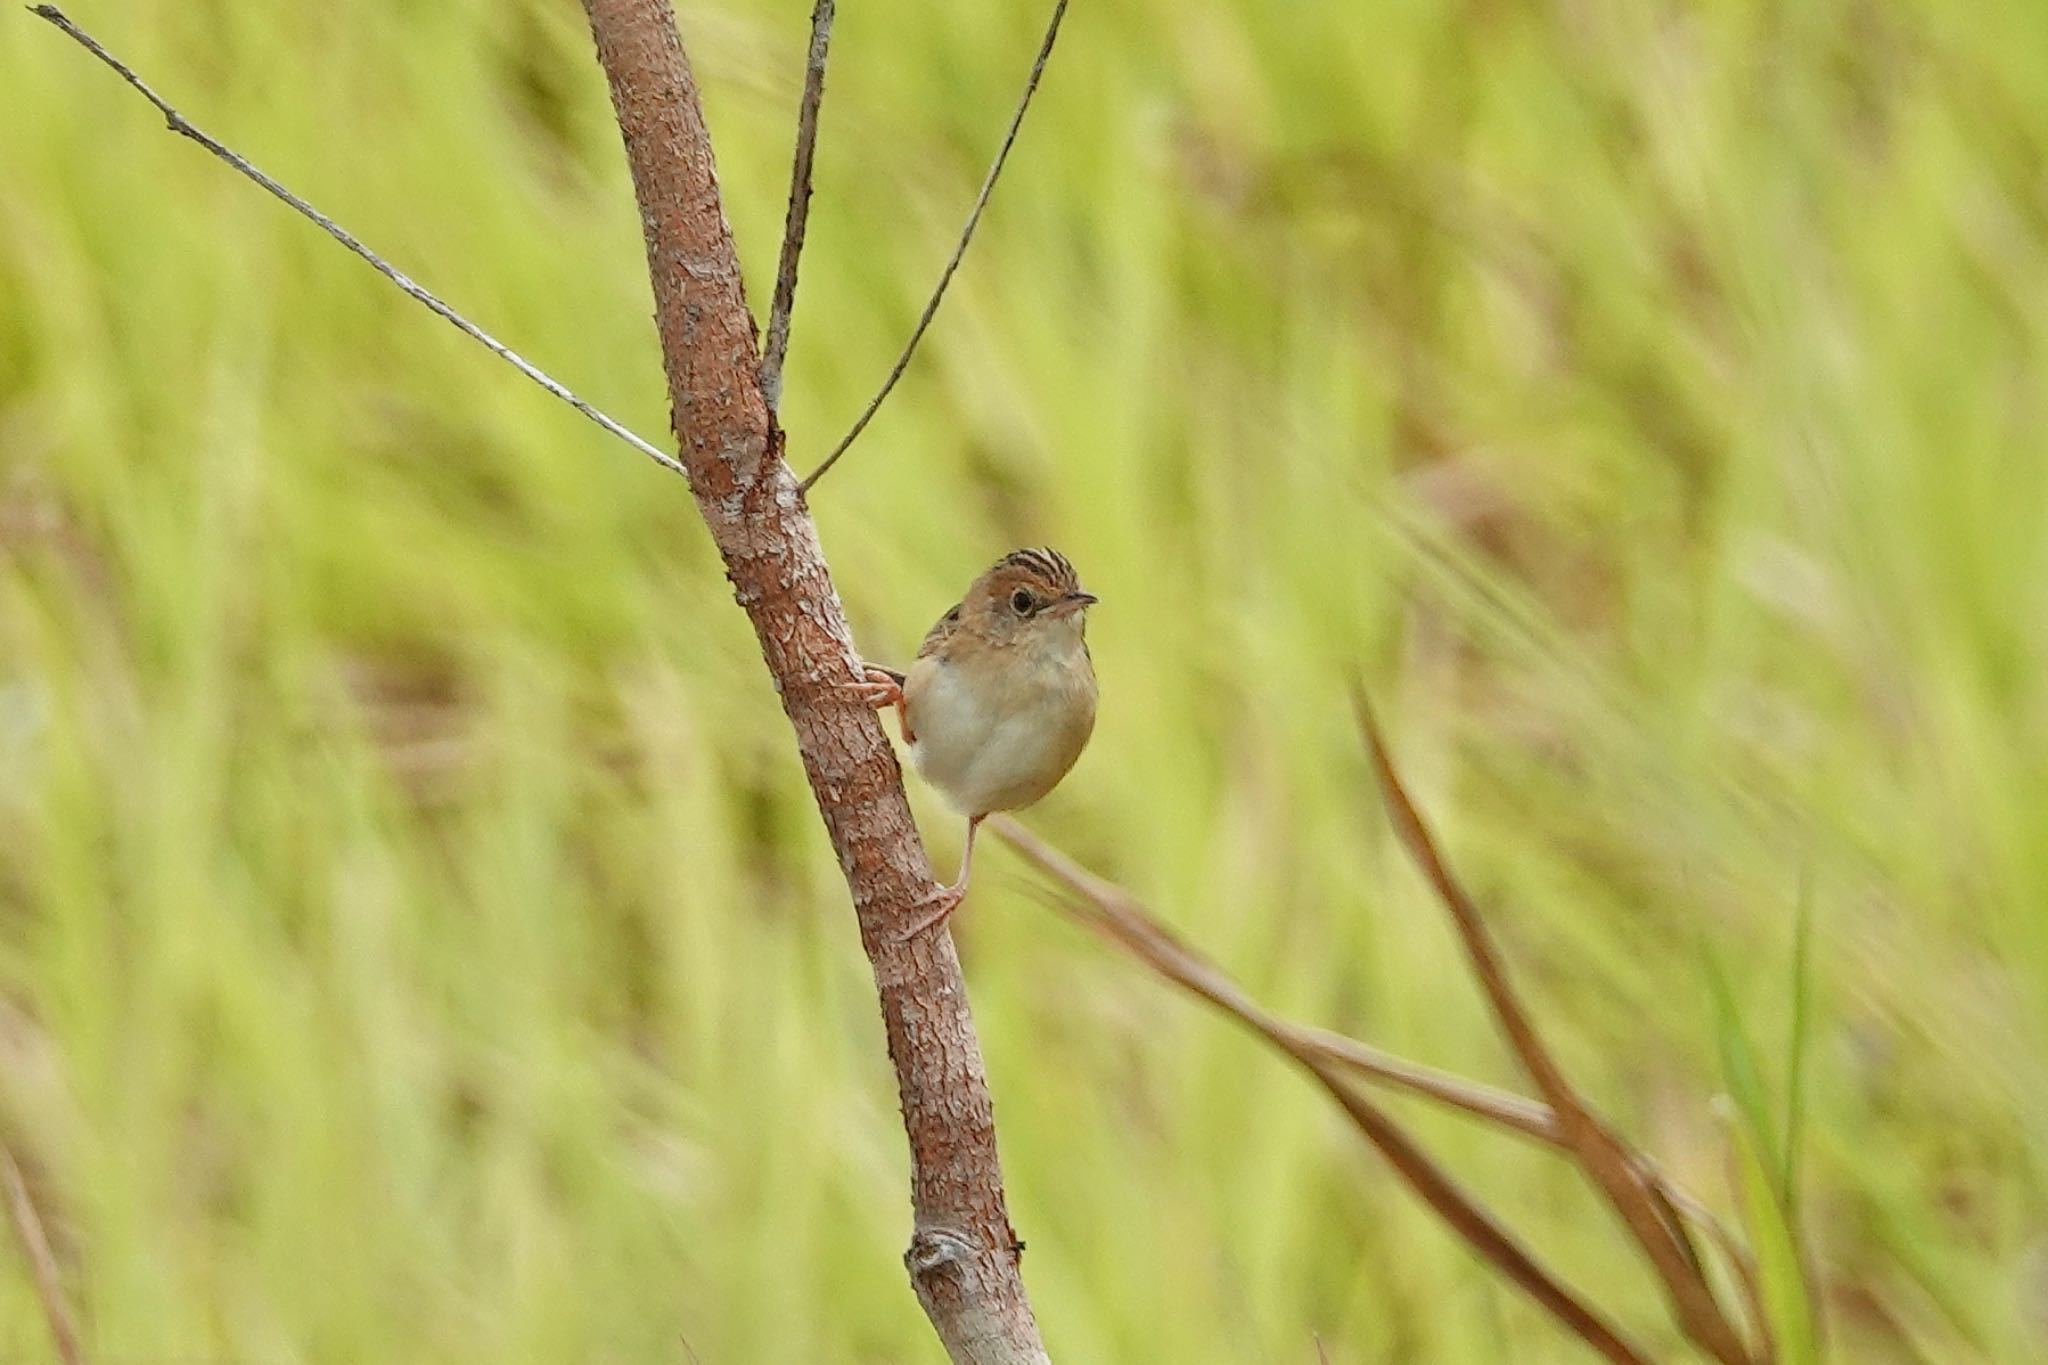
[903,653,1096,814]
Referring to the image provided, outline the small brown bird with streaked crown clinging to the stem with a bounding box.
[854,548,1096,937]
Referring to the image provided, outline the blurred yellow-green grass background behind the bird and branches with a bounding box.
[0,0,2048,1365]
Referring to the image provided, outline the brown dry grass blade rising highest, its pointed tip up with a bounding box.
[1352,692,1753,1365]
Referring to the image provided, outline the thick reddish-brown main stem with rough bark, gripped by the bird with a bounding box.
[584,0,1047,1365]
